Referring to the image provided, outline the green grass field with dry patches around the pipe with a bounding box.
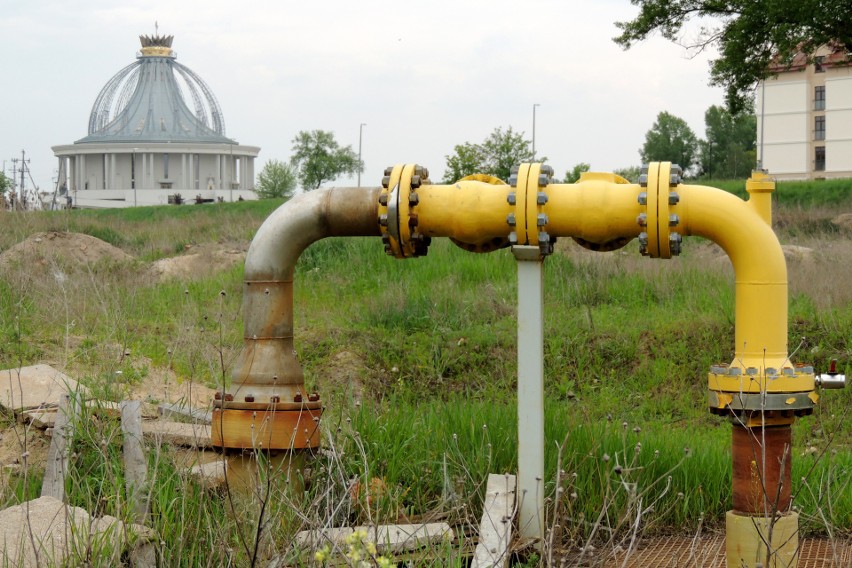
[0,182,852,566]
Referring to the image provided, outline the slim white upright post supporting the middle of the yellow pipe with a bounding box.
[512,246,544,539]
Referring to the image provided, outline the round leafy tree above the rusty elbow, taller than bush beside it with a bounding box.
[290,130,364,190]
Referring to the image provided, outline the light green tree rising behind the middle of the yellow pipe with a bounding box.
[444,126,536,183]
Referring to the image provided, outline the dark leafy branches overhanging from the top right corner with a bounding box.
[614,0,852,114]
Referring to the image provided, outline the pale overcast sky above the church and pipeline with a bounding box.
[0,0,723,191]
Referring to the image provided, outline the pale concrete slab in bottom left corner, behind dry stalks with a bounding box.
[0,497,155,568]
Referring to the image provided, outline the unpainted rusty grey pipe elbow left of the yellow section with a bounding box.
[214,188,380,447]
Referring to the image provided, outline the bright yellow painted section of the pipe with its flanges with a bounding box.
[379,162,813,392]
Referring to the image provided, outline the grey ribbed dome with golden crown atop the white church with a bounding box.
[75,35,237,144]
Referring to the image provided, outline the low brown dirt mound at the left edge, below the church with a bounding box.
[0,231,133,268]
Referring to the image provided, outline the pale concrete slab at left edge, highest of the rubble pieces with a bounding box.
[0,365,79,412]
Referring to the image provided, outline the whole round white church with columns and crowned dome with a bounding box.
[52,35,260,208]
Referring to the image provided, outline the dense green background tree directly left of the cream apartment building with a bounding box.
[698,105,757,179]
